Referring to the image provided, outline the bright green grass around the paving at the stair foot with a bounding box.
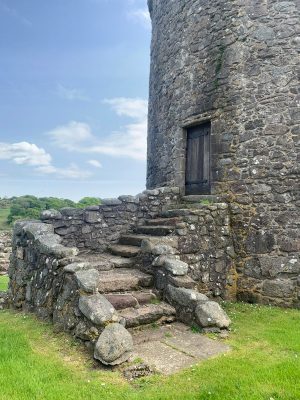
[0,304,300,400]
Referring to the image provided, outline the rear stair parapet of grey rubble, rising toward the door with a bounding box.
[41,187,179,251]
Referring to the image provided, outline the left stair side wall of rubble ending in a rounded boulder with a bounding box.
[7,221,133,365]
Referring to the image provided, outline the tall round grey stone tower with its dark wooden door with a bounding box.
[147,0,300,306]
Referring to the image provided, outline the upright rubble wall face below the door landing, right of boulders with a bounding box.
[178,203,236,300]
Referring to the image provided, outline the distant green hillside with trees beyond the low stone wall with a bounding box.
[0,195,101,230]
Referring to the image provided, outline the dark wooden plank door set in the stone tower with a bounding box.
[185,122,211,195]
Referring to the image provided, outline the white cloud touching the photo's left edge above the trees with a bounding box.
[0,142,51,166]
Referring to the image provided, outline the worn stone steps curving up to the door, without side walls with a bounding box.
[76,196,225,328]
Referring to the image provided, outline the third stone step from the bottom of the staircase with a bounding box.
[97,268,153,293]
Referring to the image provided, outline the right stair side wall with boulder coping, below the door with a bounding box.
[138,203,236,332]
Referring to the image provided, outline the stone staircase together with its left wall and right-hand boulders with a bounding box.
[10,195,230,365]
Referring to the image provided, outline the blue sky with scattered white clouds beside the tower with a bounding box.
[0,0,151,200]
